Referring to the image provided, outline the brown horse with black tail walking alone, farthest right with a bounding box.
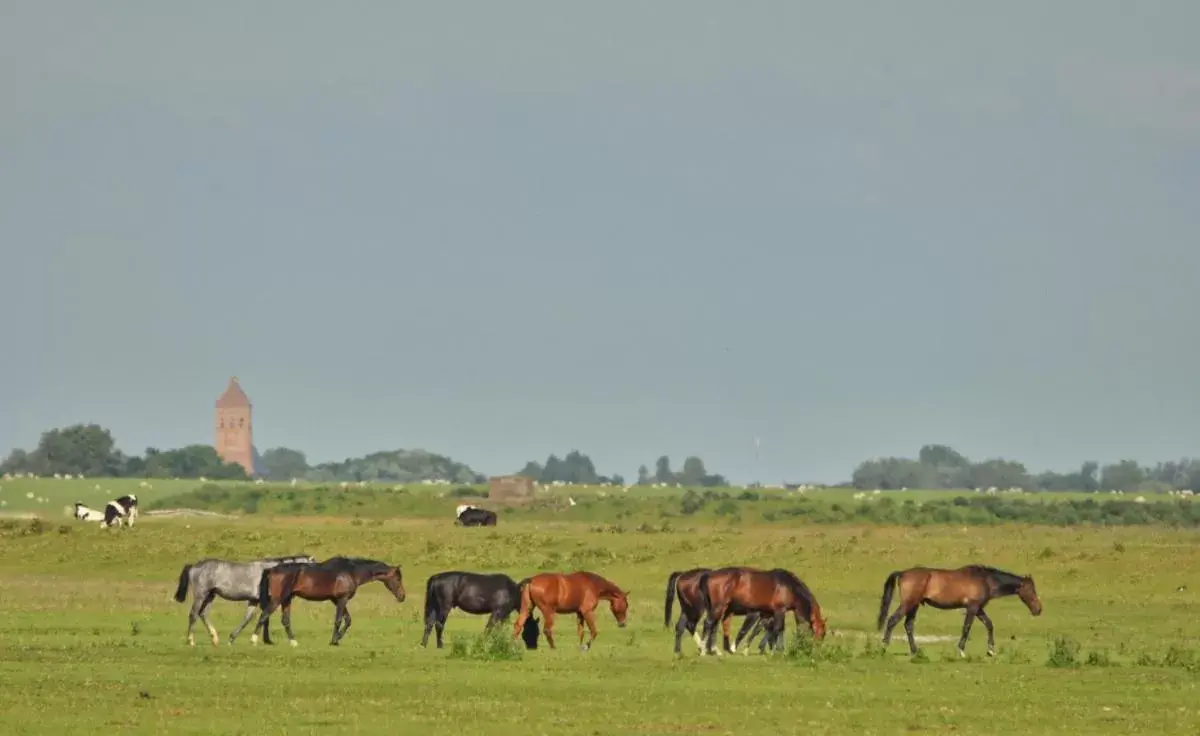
[876,564,1042,657]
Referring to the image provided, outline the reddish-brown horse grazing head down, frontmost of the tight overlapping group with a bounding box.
[697,567,826,654]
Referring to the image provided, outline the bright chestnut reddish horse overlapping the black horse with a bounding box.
[512,572,629,652]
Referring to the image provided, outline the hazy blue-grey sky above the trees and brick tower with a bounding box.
[0,0,1200,481]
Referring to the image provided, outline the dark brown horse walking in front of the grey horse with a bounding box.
[251,557,406,646]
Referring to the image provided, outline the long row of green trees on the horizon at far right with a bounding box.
[851,444,1200,492]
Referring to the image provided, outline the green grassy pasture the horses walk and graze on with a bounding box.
[0,515,1200,735]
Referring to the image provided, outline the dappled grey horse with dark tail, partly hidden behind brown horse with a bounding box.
[175,555,317,646]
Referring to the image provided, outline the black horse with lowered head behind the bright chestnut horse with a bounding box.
[421,570,539,650]
